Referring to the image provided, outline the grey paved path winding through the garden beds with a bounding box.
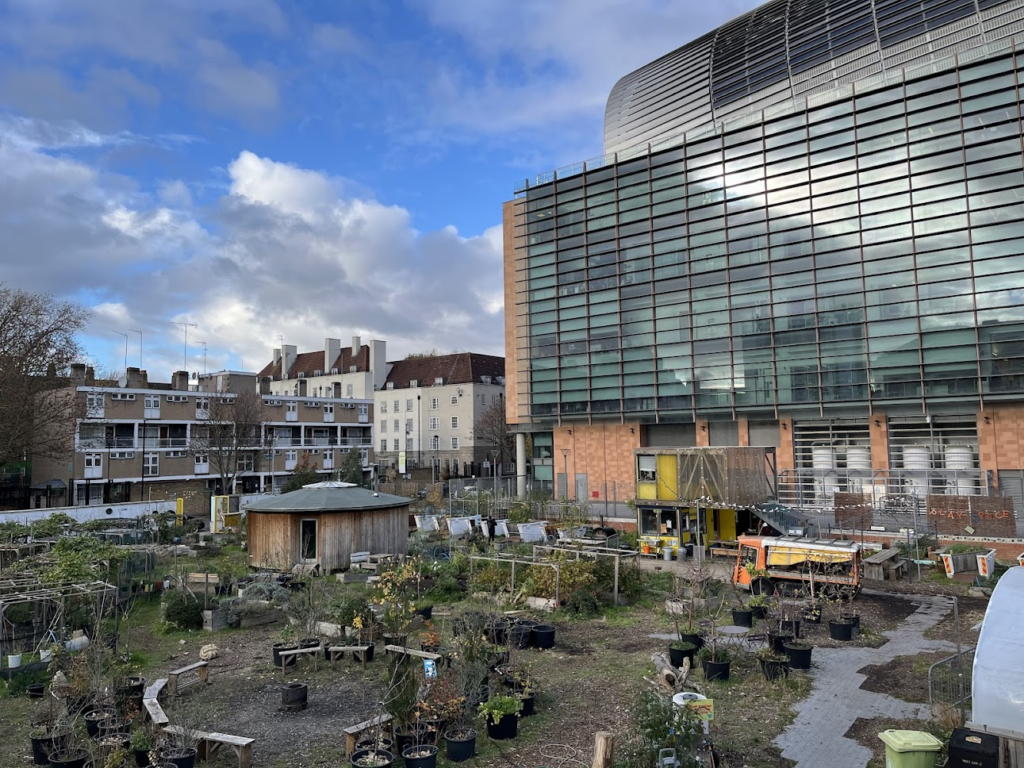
[775,595,955,768]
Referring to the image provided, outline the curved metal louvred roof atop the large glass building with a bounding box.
[604,0,1024,153]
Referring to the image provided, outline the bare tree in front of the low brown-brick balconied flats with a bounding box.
[188,392,269,494]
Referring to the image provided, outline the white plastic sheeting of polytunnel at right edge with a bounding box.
[971,567,1024,732]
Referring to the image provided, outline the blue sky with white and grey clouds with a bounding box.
[0,0,758,381]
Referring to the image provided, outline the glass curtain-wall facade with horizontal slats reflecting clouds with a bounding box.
[517,49,1024,418]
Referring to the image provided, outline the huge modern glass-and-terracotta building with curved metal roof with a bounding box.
[504,0,1024,528]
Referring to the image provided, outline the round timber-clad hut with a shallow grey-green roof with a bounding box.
[247,481,413,573]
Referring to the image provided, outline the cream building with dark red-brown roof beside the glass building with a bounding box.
[374,352,512,476]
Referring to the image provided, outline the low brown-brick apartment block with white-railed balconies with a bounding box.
[33,365,373,514]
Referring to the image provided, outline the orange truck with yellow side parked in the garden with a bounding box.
[732,536,862,597]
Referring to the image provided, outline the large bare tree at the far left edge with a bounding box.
[0,283,89,467]
